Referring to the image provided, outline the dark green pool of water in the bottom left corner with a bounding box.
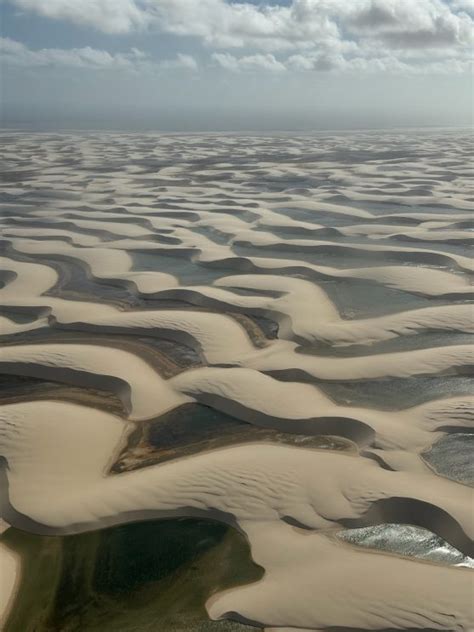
[1,519,262,632]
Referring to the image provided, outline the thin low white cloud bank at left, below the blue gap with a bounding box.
[0,37,198,72]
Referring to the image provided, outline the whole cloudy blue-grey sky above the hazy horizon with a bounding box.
[0,0,474,131]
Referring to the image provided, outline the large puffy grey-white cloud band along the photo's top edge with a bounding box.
[10,0,474,50]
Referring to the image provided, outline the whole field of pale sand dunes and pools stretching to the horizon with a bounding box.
[0,132,474,632]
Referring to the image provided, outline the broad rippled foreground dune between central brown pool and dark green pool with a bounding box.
[0,401,474,545]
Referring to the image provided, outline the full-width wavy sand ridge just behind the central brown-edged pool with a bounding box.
[0,344,474,451]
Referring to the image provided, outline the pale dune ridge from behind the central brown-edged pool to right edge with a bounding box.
[170,368,474,452]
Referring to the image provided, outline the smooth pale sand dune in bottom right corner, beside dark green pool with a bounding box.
[208,523,473,632]
